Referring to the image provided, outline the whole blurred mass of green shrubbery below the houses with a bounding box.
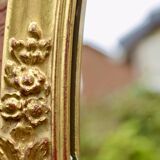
[81,86,160,160]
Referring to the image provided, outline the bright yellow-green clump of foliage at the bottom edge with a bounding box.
[97,121,160,160]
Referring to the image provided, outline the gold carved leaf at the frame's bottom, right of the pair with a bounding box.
[24,139,49,160]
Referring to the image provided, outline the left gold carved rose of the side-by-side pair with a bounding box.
[0,93,23,119]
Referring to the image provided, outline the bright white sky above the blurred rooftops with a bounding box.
[84,0,160,56]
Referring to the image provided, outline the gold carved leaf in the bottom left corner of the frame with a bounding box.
[0,138,21,160]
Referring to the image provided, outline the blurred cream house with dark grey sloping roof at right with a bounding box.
[120,8,160,92]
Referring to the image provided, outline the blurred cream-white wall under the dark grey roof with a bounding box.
[133,30,160,92]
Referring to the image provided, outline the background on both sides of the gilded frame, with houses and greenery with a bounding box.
[0,0,160,160]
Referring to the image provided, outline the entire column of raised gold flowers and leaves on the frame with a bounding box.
[0,22,51,160]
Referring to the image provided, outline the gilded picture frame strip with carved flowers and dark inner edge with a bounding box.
[0,0,85,160]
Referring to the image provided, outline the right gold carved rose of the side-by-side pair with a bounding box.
[24,98,49,126]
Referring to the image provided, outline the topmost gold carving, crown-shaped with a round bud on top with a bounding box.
[10,22,51,65]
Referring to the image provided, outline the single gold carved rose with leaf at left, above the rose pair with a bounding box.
[5,61,47,96]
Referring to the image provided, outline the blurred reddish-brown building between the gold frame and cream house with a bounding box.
[82,46,136,103]
